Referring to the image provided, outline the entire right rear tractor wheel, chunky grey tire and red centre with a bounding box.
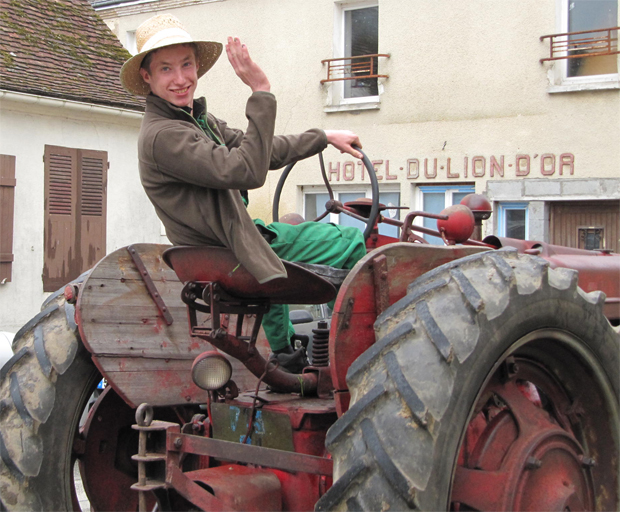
[316,250,620,511]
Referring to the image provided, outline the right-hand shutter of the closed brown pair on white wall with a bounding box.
[77,149,108,272]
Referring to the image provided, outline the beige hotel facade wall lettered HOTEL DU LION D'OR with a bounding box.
[99,0,620,232]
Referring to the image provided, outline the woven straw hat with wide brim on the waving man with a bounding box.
[121,14,222,96]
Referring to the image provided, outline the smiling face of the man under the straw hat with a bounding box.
[140,44,198,108]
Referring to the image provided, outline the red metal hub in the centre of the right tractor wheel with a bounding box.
[452,362,595,511]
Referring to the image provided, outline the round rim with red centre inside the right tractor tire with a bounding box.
[451,329,618,511]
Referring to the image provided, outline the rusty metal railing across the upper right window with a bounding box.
[540,27,620,62]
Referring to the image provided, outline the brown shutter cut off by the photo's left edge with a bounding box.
[0,155,15,283]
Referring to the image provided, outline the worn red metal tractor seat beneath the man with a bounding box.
[162,245,336,304]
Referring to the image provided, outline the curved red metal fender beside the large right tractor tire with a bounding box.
[329,242,489,416]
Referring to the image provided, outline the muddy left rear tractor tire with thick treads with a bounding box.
[0,282,101,511]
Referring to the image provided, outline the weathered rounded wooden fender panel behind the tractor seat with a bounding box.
[76,244,268,407]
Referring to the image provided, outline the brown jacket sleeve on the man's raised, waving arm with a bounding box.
[153,92,276,189]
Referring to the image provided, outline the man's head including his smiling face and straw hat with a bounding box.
[120,14,223,100]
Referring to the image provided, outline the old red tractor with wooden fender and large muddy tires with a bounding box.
[0,153,620,511]
